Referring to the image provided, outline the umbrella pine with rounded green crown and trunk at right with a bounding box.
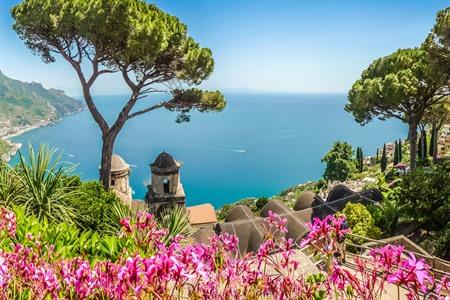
[345,48,450,169]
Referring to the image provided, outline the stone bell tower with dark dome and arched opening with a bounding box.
[147,152,186,214]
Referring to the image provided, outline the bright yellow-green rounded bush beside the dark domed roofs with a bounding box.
[342,202,381,244]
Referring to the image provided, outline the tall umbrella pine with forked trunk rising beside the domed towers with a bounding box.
[12,0,225,189]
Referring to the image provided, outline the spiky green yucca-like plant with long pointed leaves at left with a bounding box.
[15,146,77,223]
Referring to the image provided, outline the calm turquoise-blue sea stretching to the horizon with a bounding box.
[13,93,407,208]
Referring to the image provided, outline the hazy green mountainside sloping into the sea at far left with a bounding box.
[0,71,83,130]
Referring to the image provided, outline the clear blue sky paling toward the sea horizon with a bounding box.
[0,0,449,95]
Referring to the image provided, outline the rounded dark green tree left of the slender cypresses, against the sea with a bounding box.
[321,141,355,181]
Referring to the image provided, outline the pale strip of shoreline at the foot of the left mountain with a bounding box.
[0,108,84,162]
